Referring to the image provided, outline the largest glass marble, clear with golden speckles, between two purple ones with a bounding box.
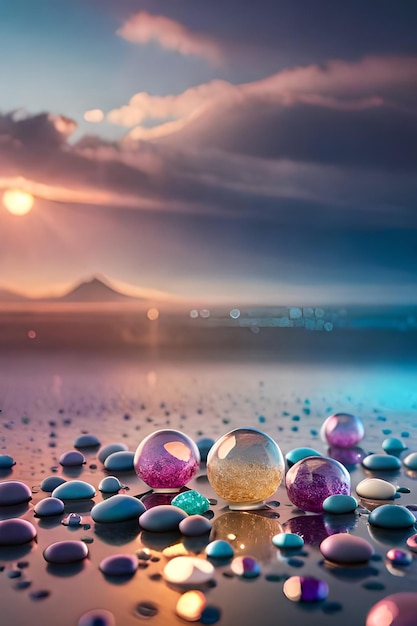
[207,428,285,510]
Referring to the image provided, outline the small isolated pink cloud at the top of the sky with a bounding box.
[117,11,222,64]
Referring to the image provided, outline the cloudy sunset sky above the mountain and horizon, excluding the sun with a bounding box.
[0,0,417,305]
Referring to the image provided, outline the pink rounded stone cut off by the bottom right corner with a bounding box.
[366,591,417,626]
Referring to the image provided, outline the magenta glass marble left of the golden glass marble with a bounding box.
[133,429,200,492]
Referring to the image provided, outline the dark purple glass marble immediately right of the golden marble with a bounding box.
[285,456,350,513]
